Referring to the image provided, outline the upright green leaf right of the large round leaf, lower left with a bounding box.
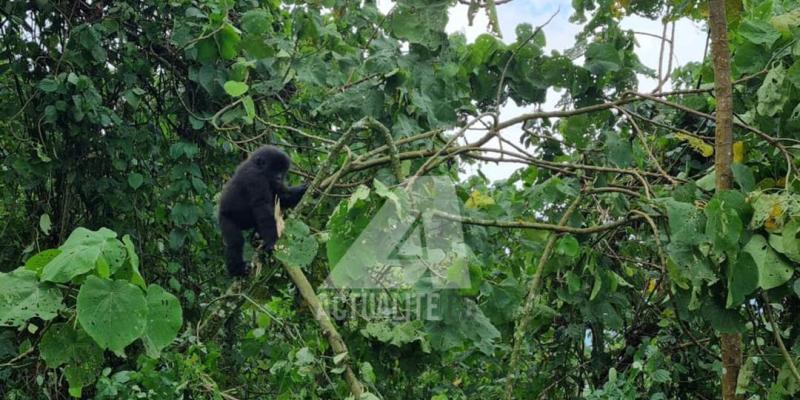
[142,285,183,358]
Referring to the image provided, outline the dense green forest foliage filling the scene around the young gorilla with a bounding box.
[0,0,800,400]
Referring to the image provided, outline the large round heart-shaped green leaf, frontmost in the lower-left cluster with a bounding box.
[77,275,147,356]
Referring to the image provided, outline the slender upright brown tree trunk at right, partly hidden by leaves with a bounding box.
[708,0,742,400]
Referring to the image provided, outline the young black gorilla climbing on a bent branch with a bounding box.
[219,146,306,276]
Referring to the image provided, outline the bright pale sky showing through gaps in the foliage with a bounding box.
[378,0,706,181]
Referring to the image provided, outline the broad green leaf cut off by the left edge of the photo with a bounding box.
[0,268,64,327]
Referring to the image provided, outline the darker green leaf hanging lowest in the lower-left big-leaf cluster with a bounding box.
[39,323,104,397]
